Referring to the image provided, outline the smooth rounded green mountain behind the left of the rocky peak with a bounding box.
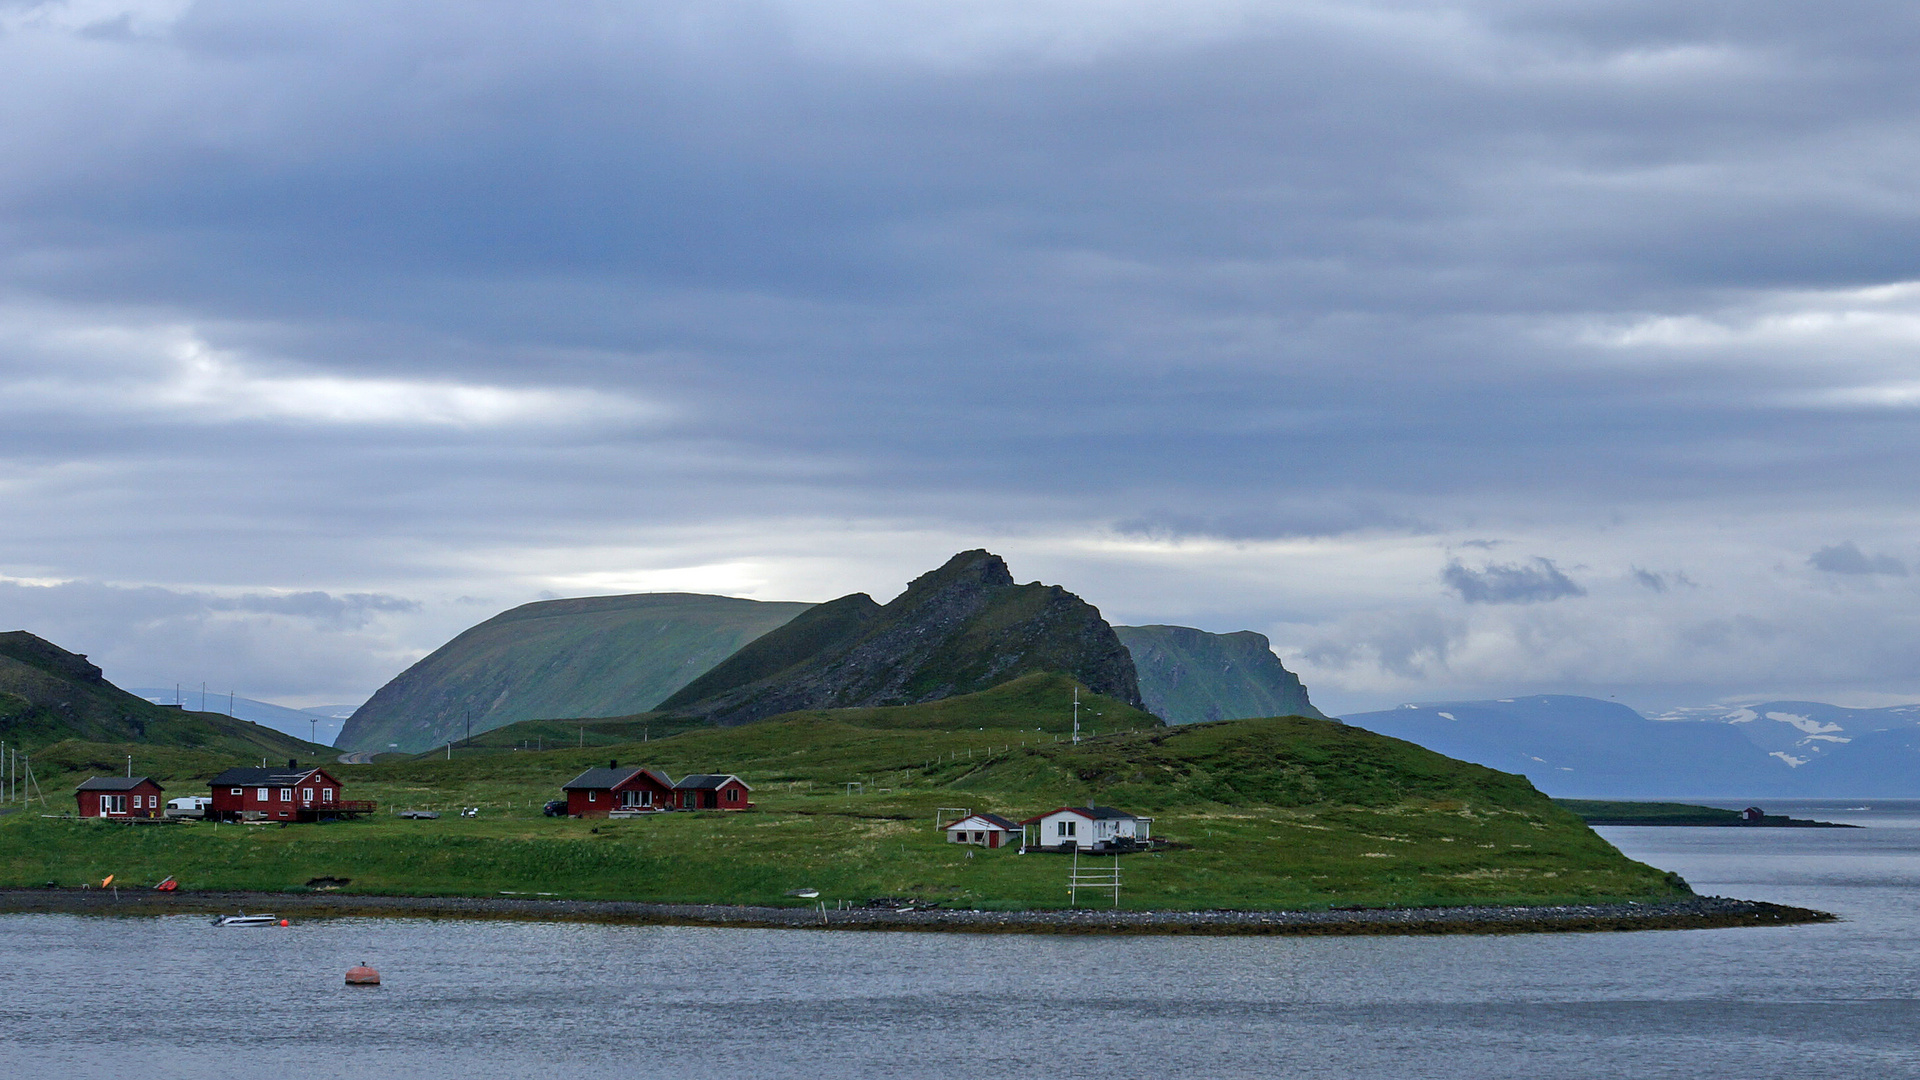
[338,592,810,751]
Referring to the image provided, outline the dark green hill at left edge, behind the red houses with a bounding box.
[0,630,330,759]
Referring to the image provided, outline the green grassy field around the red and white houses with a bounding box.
[0,676,1686,909]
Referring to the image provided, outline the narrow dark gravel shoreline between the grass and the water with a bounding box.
[0,890,1837,936]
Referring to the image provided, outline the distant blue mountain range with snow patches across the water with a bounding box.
[1344,694,1920,799]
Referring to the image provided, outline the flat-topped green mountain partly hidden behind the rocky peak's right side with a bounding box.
[1114,626,1327,724]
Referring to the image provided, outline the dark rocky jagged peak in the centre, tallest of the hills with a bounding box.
[659,550,1140,724]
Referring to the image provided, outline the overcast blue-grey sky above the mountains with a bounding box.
[0,0,1920,711]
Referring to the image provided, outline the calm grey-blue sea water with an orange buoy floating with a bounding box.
[0,803,1920,1080]
